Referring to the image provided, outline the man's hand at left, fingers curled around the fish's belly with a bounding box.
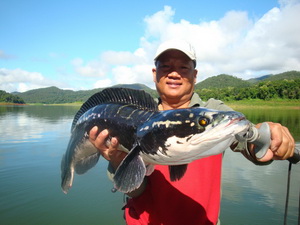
[89,126,127,169]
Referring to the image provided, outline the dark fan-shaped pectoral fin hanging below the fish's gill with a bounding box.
[114,145,146,193]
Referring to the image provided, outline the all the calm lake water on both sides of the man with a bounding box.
[0,106,300,225]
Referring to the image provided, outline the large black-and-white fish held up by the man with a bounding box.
[61,88,250,193]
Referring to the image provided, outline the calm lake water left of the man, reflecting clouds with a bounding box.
[0,106,124,225]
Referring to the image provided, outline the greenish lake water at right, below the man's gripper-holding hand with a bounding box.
[221,147,300,225]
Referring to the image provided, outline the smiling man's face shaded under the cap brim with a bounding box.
[152,50,197,101]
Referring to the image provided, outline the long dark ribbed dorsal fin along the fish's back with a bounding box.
[72,88,158,130]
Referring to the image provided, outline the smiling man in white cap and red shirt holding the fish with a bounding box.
[90,40,295,225]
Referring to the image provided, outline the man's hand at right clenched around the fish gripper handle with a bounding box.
[251,122,295,162]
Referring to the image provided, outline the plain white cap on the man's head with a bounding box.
[154,40,196,65]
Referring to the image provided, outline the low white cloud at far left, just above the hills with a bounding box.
[0,68,60,92]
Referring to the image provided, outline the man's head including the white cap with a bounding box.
[152,40,197,108]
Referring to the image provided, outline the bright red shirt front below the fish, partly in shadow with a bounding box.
[125,154,222,225]
